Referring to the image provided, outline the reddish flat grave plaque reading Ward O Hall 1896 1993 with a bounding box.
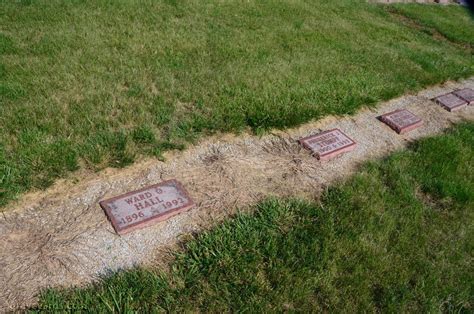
[100,180,194,234]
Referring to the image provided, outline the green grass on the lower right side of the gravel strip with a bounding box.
[38,123,474,313]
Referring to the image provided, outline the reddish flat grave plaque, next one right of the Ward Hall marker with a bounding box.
[299,129,356,160]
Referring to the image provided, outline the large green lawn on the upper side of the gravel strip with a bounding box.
[0,0,474,206]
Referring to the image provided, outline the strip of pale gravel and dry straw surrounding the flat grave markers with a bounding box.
[0,78,474,309]
